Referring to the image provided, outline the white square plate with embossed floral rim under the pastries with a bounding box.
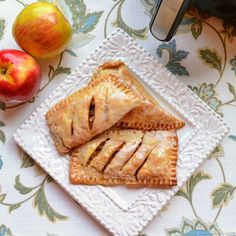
[14,30,228,236]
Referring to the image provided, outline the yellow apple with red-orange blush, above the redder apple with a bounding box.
[12,2,72,59]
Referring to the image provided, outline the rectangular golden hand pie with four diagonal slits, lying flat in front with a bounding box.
[70,129,178,187]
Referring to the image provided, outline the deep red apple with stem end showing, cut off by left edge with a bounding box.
[0,49,41,102]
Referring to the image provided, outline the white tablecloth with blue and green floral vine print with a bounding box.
[0,0,236,236]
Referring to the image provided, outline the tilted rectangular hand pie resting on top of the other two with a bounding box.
[46,75,140,154]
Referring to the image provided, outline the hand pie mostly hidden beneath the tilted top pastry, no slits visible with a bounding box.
[90,61,185,130]
